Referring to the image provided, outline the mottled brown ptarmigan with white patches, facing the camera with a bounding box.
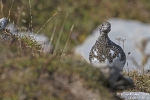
[89,22,126,70]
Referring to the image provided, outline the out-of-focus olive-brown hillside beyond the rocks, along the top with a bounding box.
[0,0,150,48]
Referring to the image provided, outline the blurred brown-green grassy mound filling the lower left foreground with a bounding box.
[0,32,115,100]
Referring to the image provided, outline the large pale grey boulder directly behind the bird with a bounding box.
[75,18,150,70]
